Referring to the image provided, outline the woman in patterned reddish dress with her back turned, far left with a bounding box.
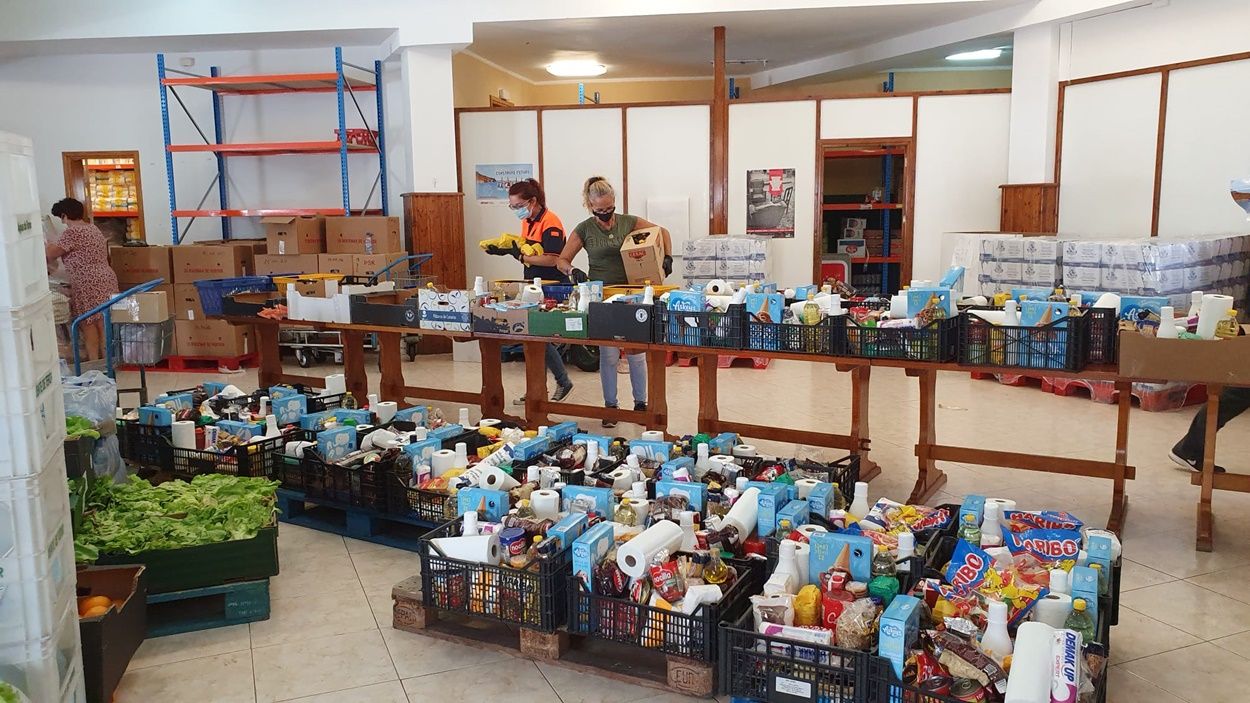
[44,198,118,360]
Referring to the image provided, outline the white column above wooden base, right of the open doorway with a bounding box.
[1008,24,1060,183]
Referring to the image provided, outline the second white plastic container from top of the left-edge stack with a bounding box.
[0,360,65,480]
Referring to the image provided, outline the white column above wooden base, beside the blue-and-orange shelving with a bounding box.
[396,45,460,193]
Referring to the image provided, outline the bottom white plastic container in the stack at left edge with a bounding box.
[0,609,86,703]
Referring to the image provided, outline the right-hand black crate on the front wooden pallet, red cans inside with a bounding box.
[568,559,764,662]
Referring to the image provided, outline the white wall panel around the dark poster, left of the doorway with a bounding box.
[729,100,816,286]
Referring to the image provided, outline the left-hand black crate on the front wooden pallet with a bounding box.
[416,518,571,632]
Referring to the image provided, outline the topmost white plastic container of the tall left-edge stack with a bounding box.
[0,133,48,308]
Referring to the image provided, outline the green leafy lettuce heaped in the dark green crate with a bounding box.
[74,474,279,562]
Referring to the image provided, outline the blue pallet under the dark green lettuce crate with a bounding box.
[148,578,269,637]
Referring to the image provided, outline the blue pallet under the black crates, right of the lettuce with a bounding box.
[278,488,438,552]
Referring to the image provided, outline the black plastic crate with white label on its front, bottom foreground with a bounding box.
[718,609,875,703]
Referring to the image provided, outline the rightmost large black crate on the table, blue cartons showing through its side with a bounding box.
[958,307,1090,372]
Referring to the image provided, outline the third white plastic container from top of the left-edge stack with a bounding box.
[0,448,73,560]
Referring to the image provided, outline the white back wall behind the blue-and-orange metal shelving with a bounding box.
[0,48,408,244]
